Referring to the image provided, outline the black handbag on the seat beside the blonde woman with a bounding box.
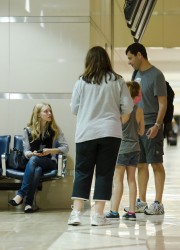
[7,148,28,171]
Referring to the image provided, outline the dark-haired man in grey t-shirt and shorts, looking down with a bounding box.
[125,43,167,215]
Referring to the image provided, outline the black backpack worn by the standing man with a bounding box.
[132,70,175,137]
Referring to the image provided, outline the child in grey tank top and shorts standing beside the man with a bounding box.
[106,81,144,220]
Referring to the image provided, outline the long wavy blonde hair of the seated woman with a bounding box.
[27,103,60,141]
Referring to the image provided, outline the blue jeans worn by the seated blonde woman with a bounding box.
[17,156,57,206]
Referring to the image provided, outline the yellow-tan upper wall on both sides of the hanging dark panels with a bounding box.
[114,0,180,48]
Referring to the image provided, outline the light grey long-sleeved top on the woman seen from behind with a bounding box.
[70,76,133,143]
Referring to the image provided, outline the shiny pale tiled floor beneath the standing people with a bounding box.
[0,140,180,250]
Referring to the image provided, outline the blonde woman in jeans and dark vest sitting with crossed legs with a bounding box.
[9,103,69,213]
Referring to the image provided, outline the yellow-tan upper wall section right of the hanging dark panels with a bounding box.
[142,0,180,48]
